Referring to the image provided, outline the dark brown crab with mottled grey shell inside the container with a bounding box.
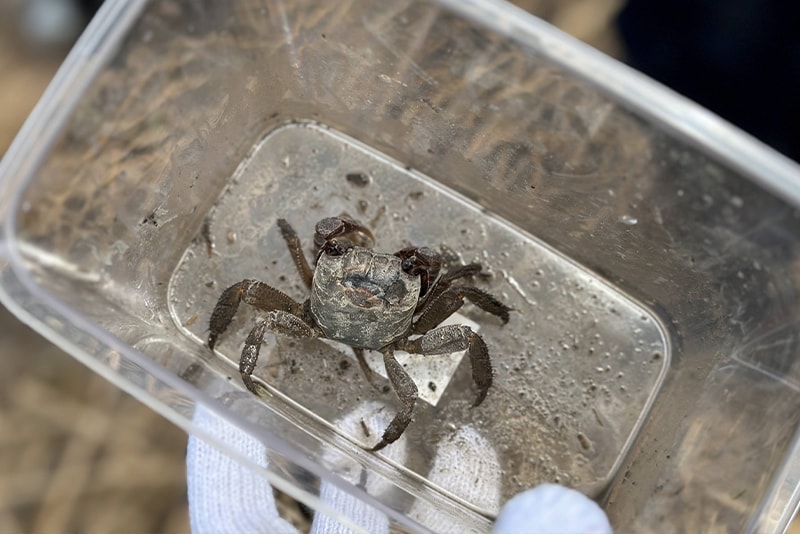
[208,217,511,451]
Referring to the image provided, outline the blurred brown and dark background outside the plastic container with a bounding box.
[0,0,800,534]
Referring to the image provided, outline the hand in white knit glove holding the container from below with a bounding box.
[186,403,611,534]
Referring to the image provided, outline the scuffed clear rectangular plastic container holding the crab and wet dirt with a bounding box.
[0,0,800,531]
